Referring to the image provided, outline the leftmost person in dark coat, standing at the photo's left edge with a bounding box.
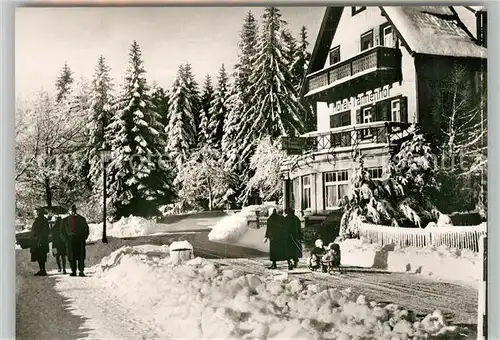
[30,209,50,276]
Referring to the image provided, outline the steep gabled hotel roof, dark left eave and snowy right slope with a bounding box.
[300,6,487,95]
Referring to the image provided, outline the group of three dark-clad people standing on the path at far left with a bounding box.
[30,205,90,276]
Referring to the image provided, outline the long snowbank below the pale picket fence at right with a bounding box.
[340,240,482,284]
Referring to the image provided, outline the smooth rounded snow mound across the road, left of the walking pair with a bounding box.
[208,204,278,243]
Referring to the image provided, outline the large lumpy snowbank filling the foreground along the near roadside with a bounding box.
[14,245,461,339]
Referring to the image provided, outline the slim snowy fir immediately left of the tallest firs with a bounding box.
[208,64,229,149]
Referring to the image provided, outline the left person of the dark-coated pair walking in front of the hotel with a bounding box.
[264,208,292,269]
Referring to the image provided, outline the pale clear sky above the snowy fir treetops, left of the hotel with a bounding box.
[15,7,325,100]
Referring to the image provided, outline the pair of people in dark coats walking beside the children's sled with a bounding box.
[264,207,302,270]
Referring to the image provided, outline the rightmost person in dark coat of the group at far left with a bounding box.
[61,204,90,276]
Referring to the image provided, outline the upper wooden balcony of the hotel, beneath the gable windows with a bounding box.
[305,46,402,101]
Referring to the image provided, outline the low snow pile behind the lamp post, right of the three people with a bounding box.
[88,216,157,241]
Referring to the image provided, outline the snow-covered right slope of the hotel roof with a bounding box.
[382,6,487,58]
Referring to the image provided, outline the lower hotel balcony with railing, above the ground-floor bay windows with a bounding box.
[281,121,411,163]
